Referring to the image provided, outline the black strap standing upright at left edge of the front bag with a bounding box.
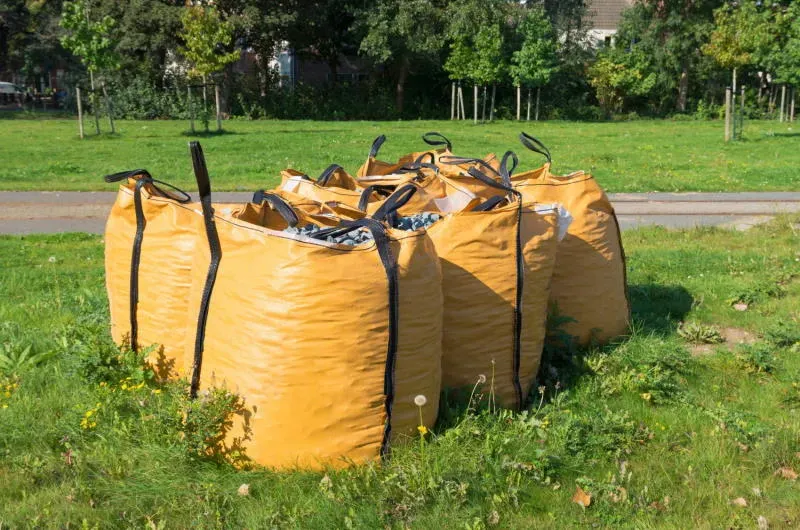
[189,142,222,398]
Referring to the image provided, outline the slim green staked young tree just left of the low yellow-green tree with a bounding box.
[510,7,557,120]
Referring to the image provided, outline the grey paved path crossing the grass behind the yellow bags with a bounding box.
[0,191,800,234]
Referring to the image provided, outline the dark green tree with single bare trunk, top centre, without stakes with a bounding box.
[357,0,444,114]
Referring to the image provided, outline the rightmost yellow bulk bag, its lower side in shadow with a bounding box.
[511,133,630,344]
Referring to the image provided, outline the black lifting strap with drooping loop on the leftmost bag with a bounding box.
[103,169,191,351]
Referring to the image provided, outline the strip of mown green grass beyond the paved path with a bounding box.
[0,119,800,192]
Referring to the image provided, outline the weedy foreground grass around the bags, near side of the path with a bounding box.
[0,217,800,529]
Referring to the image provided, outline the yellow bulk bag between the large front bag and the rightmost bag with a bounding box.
[375,177,559,408]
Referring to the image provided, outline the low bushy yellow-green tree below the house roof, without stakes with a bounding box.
[588,48,656,114]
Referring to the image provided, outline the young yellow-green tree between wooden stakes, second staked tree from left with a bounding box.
[181,5,241,131]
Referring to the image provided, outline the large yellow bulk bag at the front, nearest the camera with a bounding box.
[186,142,442,469]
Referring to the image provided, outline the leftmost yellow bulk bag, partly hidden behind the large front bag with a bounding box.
[105,169,316,377]
